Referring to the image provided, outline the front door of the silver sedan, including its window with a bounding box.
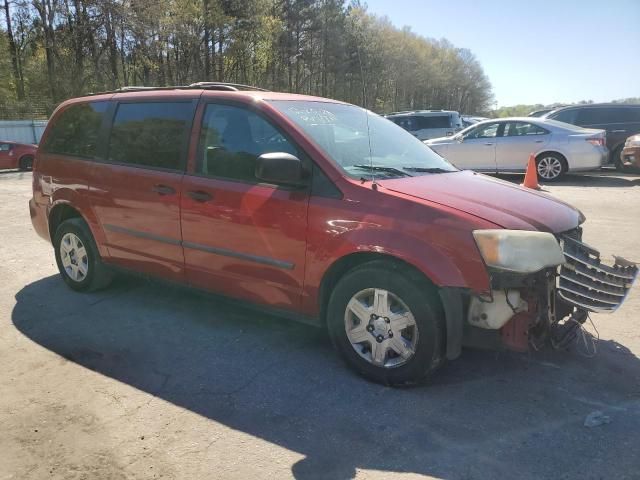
[447,122,501,173]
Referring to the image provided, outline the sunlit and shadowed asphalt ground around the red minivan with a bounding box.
[0,172,640,480]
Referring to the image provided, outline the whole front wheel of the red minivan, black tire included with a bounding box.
[327,261,445,386]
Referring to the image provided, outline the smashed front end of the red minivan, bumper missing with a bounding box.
[463,227,638,351]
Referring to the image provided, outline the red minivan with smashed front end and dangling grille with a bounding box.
[29,83,638,385]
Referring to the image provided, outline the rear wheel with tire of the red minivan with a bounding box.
[53,218,113,292]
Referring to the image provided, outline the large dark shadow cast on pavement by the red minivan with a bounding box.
[12,276,640,479]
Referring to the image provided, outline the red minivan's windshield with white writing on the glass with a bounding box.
[271,100,457,178]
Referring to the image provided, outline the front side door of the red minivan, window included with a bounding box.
[181,103,309,310]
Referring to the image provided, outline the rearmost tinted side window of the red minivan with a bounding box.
[44,102,108,158]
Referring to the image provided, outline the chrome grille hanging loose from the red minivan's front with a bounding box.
[558,235,638,312]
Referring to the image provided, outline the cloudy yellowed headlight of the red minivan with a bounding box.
[473,230,564,273]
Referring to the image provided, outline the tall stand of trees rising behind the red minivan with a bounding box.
[0,0,492,117]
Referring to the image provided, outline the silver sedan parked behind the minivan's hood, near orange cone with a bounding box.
[424,117,609,181]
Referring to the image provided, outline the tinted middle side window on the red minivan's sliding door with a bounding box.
[109,102,193,170]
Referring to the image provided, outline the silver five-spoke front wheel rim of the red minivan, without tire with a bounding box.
[344,288,418,368]
